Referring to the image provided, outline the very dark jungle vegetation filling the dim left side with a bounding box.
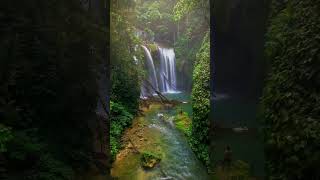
[0,0,107,180]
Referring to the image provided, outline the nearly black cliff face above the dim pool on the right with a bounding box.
[212,0,269,99]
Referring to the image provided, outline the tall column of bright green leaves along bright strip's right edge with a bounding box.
[191,33,210,165]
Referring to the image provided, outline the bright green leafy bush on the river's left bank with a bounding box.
[110,101,133,159]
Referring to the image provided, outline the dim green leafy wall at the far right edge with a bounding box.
[261,0,320,180]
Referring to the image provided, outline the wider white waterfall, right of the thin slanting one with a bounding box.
[158,47,177,93]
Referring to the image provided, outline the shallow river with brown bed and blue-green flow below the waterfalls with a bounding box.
[111,93,208,180]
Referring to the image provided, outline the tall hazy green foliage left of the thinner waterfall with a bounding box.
[110,5,144,113]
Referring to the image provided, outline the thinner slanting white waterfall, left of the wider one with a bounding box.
[141,45,159,97]
